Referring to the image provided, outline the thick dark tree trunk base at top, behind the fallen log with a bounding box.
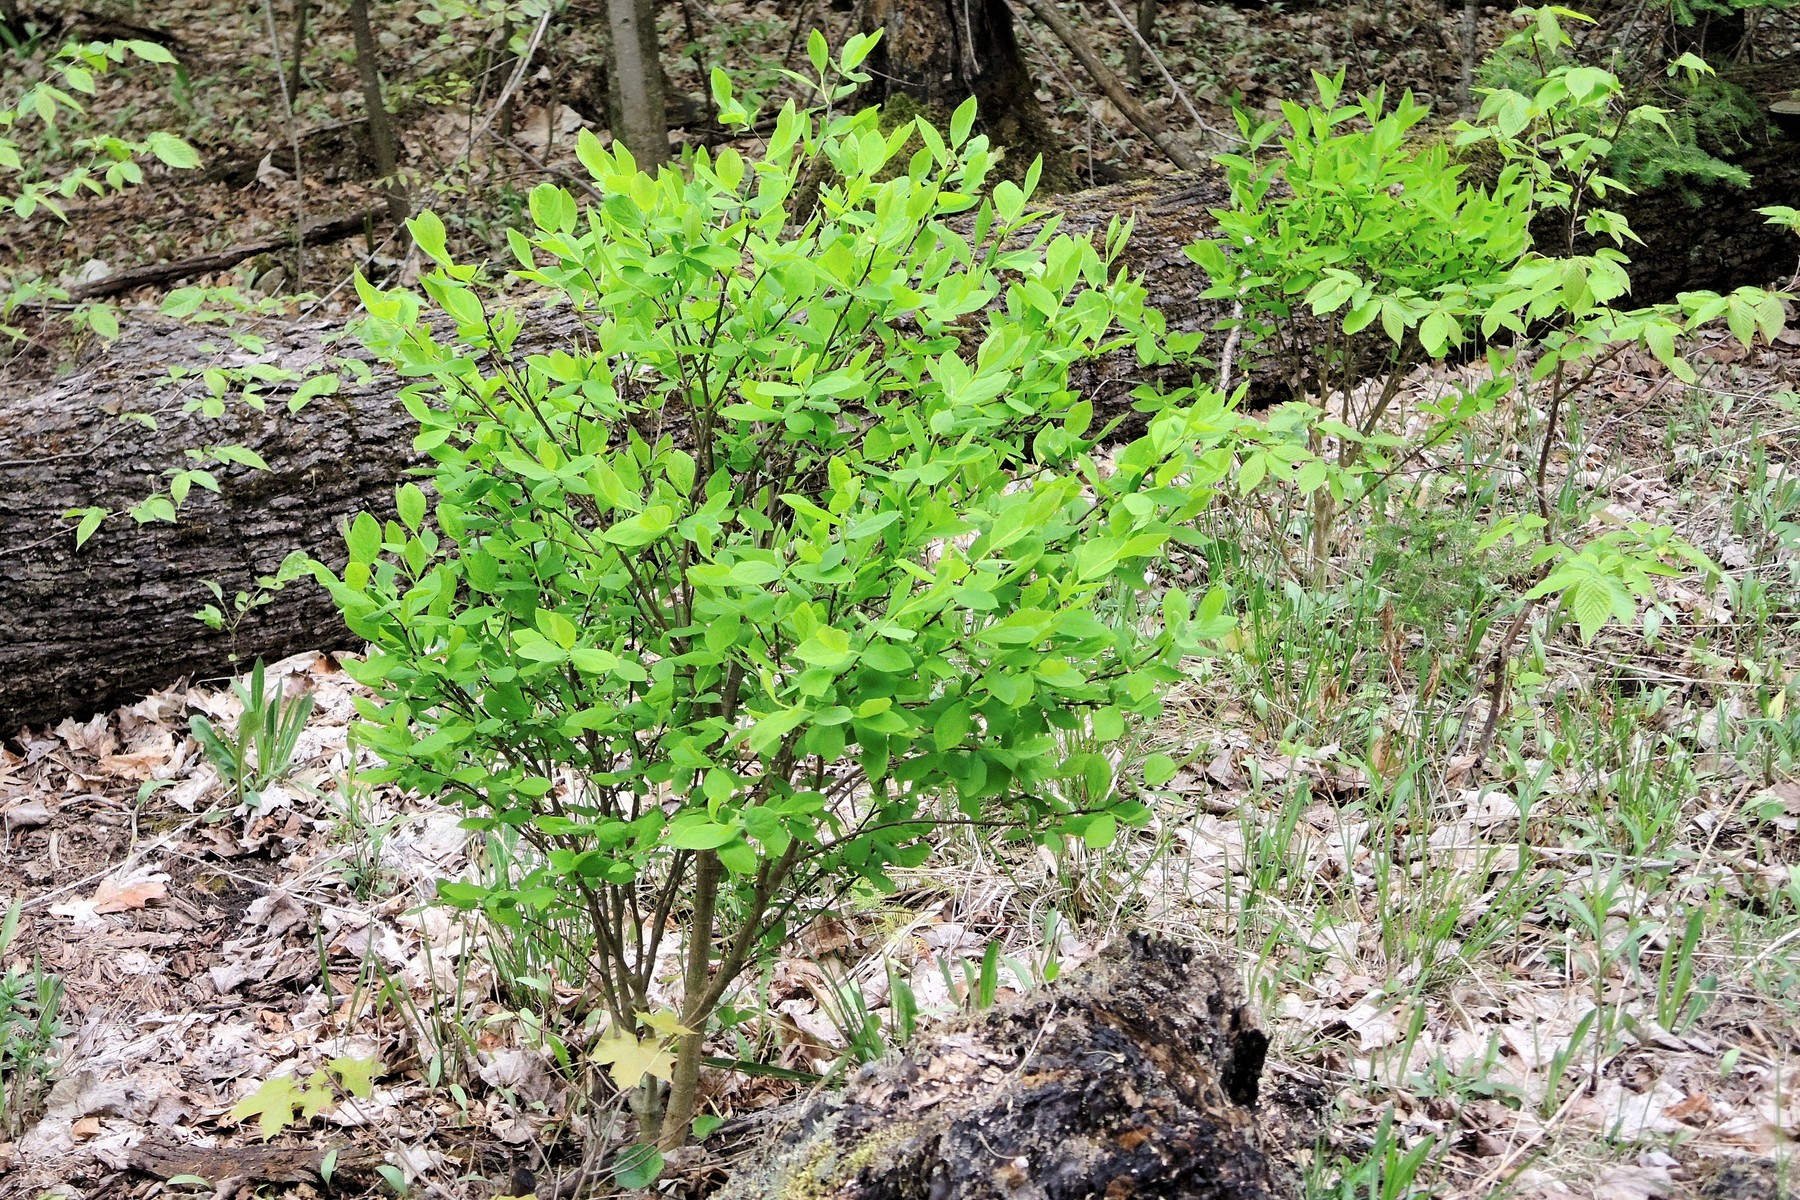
[859,0,1076,193]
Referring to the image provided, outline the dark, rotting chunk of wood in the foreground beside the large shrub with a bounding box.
[722,936,1296,1200]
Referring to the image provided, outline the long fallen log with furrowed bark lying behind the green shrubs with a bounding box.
[0,107,1800,736]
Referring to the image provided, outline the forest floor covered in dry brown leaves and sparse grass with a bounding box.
[0,4,1800,1200]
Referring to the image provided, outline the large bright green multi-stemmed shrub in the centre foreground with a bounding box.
[319,34,1237,1162]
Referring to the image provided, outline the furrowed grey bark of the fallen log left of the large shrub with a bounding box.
[0,324,416,738]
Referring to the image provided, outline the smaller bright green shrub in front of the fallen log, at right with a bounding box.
[1188,72,1534,569]
